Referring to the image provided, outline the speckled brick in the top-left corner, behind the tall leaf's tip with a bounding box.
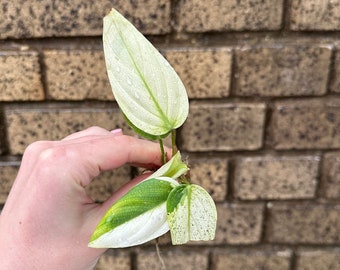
[0,0,170,39]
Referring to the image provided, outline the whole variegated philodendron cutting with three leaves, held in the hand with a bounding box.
[89,9,217,248]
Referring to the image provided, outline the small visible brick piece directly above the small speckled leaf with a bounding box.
[189,158,228,201]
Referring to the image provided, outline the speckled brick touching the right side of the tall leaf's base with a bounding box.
[182,102,265,151]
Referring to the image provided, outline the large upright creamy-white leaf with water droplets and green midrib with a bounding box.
[103,9,189,139]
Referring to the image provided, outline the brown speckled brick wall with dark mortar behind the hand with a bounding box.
[0,0,340,270]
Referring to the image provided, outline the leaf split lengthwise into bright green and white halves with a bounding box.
[89,177,178,248]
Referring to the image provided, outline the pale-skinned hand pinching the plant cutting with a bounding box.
[0,127,170,270]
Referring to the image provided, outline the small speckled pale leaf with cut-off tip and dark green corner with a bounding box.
[167,184,217,245]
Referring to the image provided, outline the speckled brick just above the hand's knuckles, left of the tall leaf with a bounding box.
[5,104,131,154]
